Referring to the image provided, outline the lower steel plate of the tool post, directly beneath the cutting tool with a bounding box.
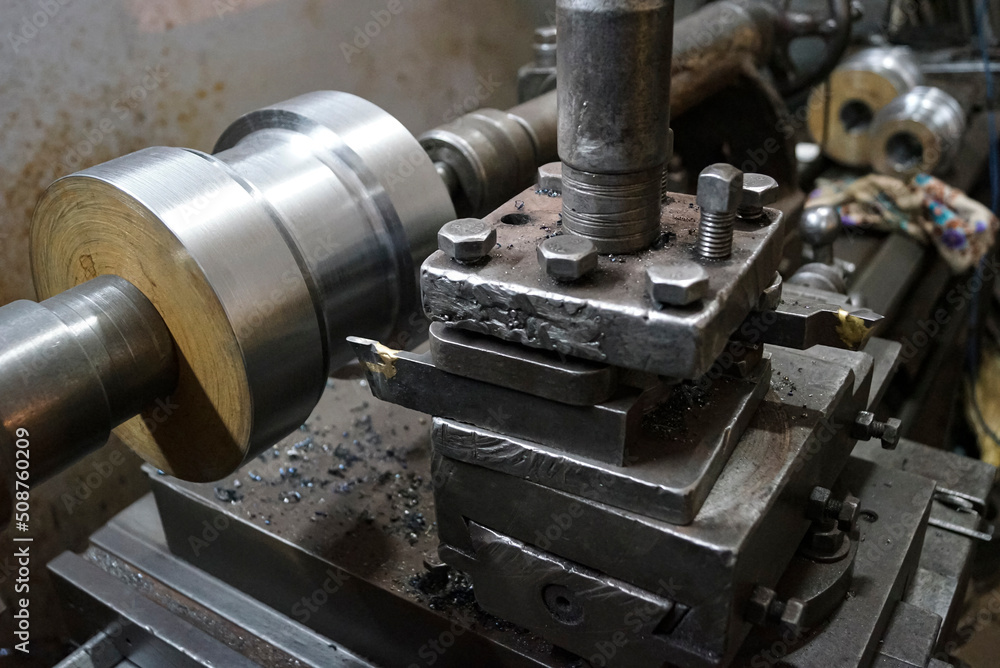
[431,360,771,524]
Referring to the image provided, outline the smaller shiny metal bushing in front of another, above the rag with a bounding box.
[871,86,966,180]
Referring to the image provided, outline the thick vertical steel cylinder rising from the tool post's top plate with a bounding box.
[556,0,674,253]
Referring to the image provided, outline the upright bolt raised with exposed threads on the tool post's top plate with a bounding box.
[697,163,743,260]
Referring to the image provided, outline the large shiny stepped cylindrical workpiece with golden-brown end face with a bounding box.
[31,92,455,481]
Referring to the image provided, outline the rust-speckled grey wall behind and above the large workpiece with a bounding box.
[0,0,554,304]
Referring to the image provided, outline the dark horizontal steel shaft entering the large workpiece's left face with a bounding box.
[0,276,177,525]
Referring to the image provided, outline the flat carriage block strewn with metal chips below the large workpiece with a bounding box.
[152,380,567,666]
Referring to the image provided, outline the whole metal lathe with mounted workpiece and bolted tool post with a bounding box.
[0,0,994,668]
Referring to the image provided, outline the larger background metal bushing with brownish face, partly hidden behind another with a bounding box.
[808,47,923,167]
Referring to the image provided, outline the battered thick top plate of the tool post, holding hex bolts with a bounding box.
[420,189,782,379]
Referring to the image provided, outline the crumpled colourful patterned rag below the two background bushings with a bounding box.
[807,174,1000,274]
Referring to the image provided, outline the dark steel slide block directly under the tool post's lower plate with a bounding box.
[433,349,872,665]
